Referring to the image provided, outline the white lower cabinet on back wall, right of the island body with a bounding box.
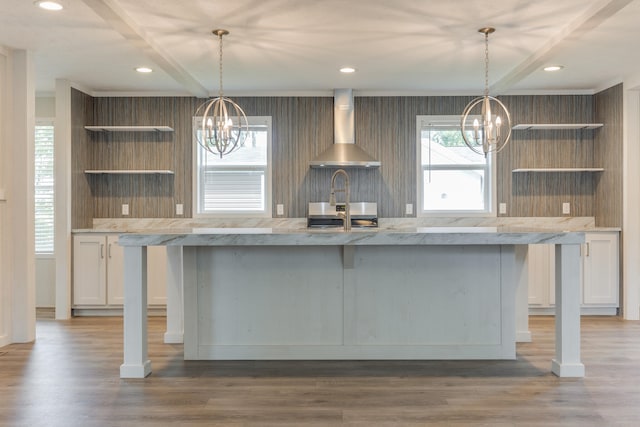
[527,231,620,315]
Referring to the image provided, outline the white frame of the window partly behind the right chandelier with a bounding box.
[416,115,497,217]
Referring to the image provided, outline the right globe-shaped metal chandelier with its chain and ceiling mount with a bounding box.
[460,27,511,157]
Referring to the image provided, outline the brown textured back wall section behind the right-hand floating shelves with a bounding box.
[497,95,599,217]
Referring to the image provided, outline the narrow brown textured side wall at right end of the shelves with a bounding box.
[594,84,623,227]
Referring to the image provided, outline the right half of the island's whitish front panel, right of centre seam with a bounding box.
[345,245,515,359]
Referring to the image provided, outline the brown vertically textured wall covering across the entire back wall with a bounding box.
[72,91,622,228]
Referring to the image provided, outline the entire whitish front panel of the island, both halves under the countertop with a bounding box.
[185,245,515,359]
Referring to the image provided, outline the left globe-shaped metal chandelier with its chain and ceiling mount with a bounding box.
[196,30,249,158]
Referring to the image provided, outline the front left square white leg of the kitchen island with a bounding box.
[120,246,151,378]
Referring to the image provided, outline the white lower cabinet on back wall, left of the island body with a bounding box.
[73,233,167,314]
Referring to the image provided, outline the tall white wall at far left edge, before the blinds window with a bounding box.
[0,47,35,345]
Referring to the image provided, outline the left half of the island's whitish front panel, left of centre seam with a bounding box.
[194,246,343,359]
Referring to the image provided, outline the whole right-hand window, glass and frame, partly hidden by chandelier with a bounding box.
[417,116,495,216]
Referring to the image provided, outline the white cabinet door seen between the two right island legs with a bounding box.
[527,245,555,308]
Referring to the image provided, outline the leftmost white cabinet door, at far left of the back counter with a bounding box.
[73,235,107,305]
